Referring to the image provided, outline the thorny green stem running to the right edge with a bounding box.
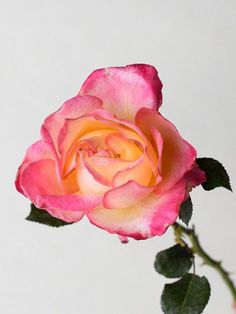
[173,223,236,304]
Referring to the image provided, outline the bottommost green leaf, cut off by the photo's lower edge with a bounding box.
[161,274,210,314]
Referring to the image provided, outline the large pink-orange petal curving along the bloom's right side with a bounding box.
[136,108,196,193]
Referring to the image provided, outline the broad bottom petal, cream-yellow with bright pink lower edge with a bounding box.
[87,180,185,240]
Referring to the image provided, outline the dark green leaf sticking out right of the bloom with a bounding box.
[196,158,232,191]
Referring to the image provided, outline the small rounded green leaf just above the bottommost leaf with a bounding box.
[154,244,193,278]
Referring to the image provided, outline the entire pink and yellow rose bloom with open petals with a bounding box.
[16,64,205,242]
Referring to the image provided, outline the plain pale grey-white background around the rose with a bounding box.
[0,0,236,314]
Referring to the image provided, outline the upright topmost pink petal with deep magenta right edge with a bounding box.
[79,64,162,121]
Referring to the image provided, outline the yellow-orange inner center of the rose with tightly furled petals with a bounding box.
[62,123,153,193]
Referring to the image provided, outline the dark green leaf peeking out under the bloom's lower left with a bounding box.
[25,204,71,227]
